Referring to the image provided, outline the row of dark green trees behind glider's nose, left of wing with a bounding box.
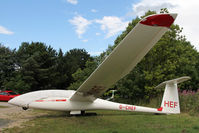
[0,42,91,93]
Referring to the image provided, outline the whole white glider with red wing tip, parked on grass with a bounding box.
[8,13,190,114]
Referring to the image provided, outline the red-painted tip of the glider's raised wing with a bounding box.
[140,13,177,28]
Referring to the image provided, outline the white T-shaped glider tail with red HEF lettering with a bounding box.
[156,76,190,114]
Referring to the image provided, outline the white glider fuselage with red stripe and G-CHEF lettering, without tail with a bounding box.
[9,90,164,113]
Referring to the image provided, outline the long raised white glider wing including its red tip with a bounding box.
[70,14,177,102]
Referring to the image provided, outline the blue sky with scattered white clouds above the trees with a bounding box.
[0,0,199,55]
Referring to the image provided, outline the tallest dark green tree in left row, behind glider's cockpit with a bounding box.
[16,42,57,91]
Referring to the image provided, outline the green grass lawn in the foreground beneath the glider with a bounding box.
[2,111,199,133]
